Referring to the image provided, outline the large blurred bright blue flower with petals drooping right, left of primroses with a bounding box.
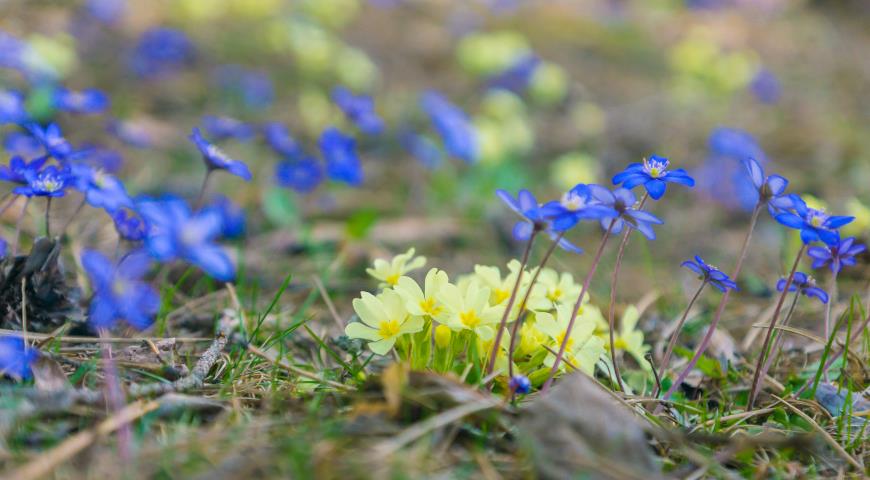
[137,197,236,282]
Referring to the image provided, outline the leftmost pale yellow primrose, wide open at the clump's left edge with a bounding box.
[344,290,423,355]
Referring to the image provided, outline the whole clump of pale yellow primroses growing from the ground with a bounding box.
[345,249,649,385]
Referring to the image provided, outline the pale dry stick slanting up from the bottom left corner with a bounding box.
[6,400,160,480]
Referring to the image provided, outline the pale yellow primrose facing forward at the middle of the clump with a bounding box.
[438,281,504,340]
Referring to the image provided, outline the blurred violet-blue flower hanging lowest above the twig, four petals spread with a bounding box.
[82,250,160,330]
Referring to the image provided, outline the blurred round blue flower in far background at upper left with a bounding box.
[130,27,194,78]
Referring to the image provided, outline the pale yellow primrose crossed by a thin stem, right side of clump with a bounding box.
[535,305,605,375]
